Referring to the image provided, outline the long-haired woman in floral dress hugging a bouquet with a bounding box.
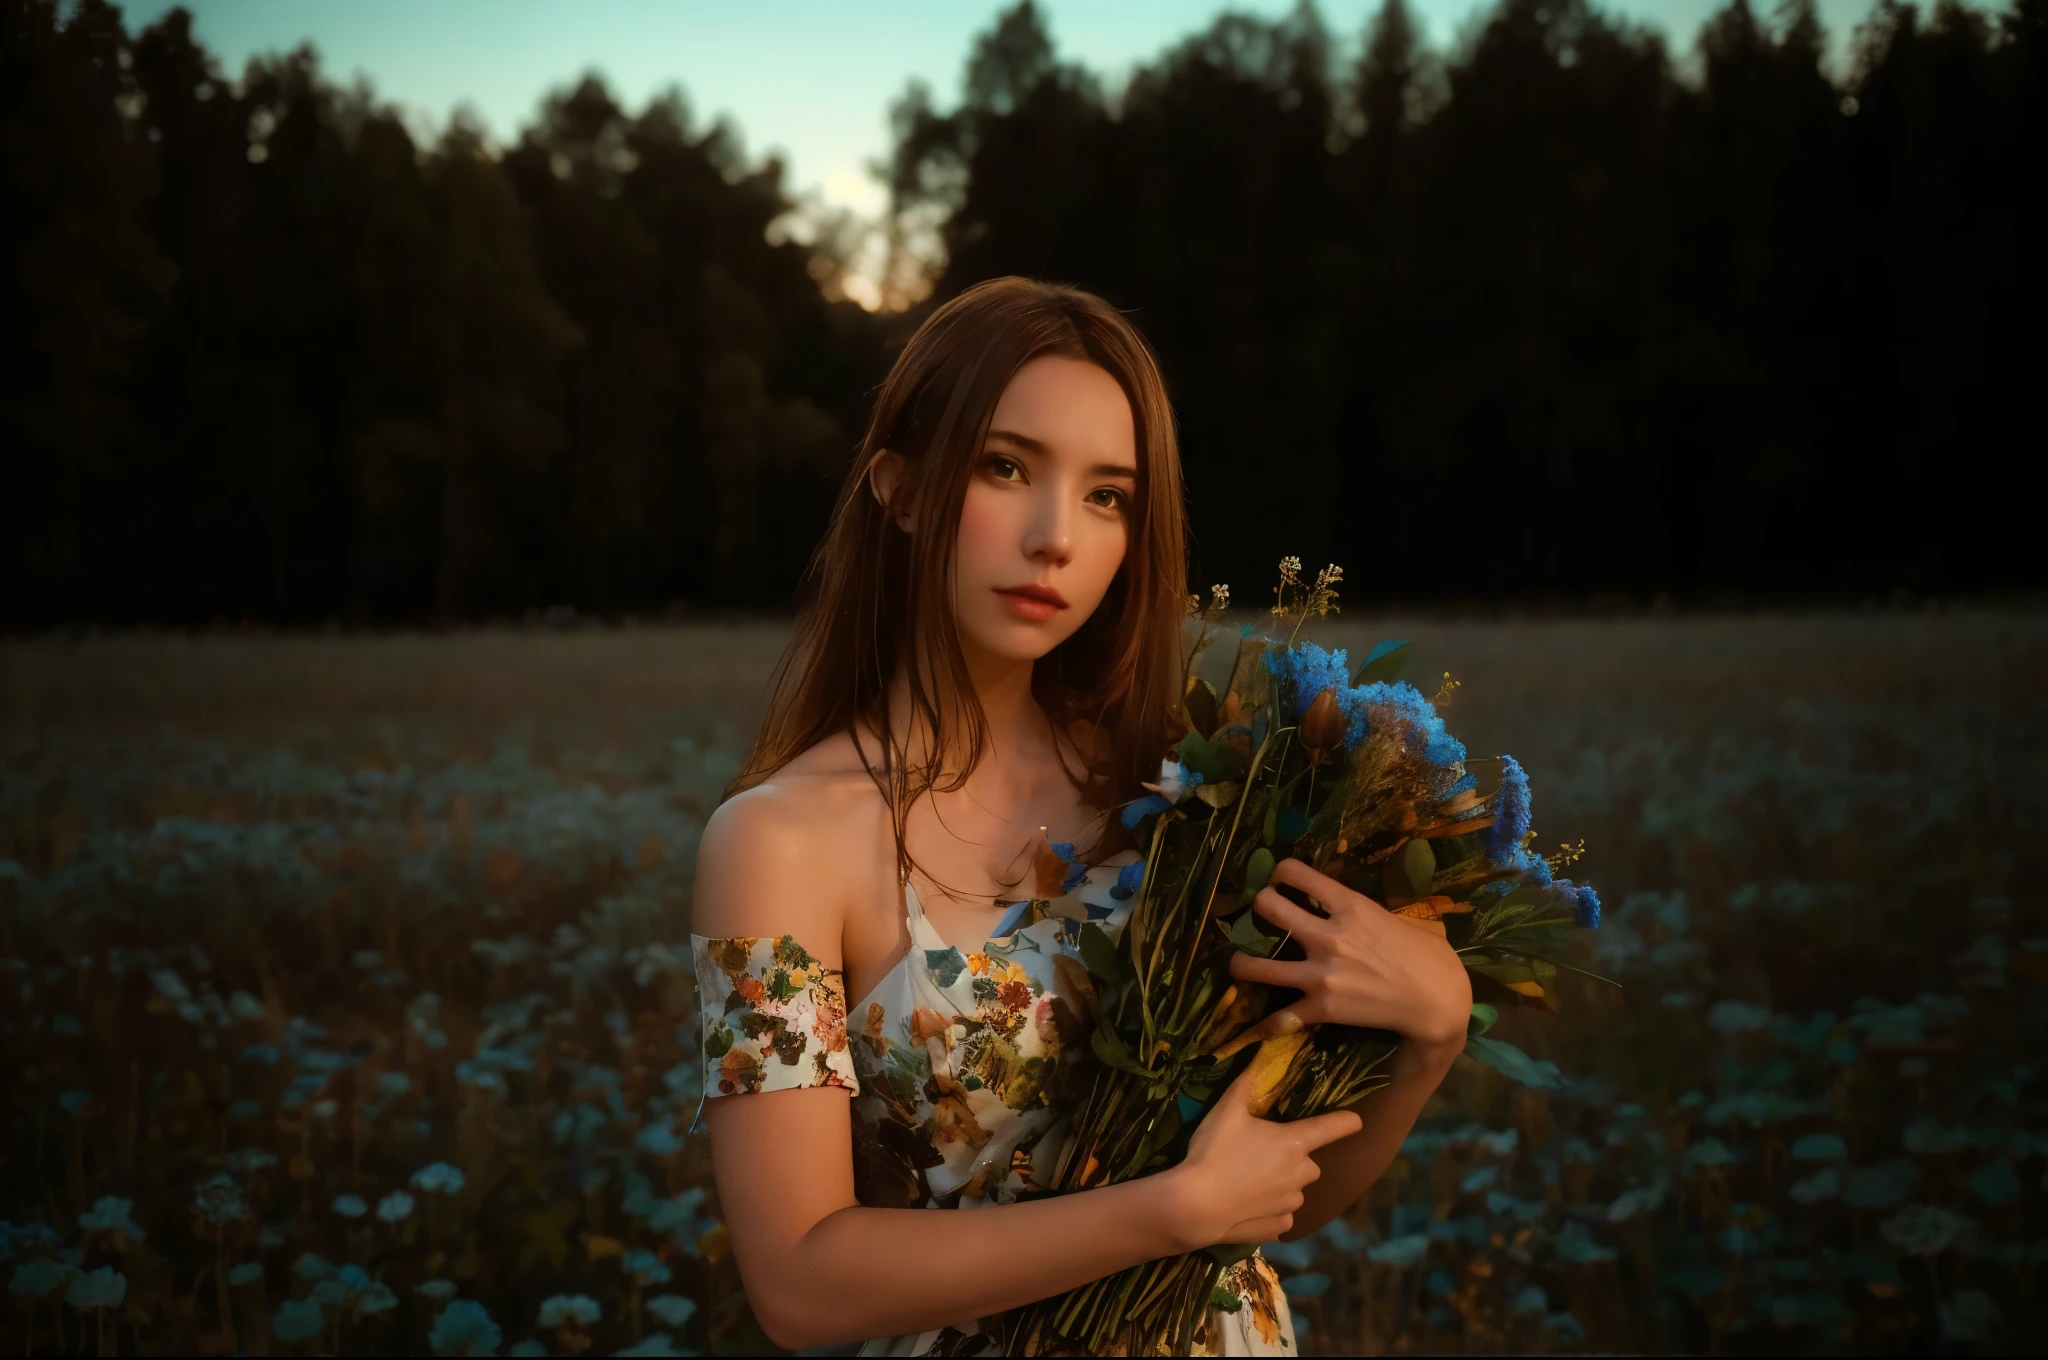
[692,279,1470,1356]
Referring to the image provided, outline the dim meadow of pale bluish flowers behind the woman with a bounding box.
[0,612,2048,1354]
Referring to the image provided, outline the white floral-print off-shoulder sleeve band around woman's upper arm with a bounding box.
[690,934,860,1096]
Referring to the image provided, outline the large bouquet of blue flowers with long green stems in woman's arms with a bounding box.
[997,557,1599,1356]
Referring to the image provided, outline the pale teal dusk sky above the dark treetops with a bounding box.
[123,0,1870,213]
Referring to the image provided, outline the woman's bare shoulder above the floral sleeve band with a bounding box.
[690,733,895,957]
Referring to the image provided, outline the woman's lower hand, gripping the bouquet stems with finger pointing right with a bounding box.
[1159,1067,1364,1251]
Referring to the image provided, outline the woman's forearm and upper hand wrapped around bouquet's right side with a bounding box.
[1231,860,1473,1237]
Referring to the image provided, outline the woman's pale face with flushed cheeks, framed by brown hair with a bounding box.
[952,356,1139,662]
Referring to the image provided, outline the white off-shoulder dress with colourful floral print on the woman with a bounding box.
[690,850,1296,1356]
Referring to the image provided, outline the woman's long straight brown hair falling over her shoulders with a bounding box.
[725,279,1188,888]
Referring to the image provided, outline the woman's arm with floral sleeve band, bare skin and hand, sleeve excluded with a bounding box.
[692,795,1360,1348]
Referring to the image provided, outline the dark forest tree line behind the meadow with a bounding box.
[0,0,2048,627]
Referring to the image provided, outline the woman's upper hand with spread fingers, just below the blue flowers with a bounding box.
[1231,860,1473,1047]
